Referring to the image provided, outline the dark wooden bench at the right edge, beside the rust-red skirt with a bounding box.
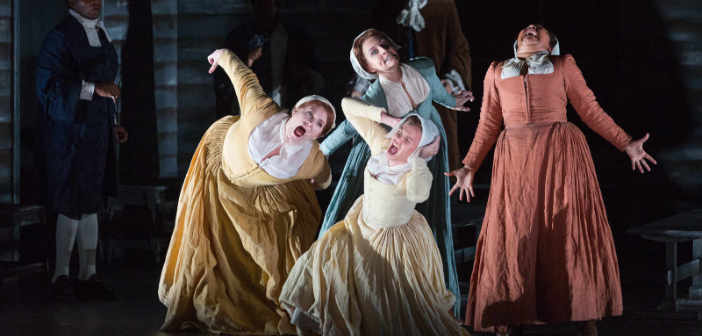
[627,209,702,317]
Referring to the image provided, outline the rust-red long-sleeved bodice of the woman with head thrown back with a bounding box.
[463,55,631,170]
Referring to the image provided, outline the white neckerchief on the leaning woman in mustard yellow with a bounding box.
[248,112,312,179]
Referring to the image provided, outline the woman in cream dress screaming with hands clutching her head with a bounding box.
[280,98,467,335]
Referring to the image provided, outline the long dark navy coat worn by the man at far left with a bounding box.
[36,15,119,219]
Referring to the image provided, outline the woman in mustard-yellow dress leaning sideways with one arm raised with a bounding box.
[158,49,335,335]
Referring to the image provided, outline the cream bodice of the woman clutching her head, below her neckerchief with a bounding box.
[362,169,417,229]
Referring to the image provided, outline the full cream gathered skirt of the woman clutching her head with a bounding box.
[280,196,467,335]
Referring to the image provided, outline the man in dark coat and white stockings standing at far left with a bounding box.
[36,0,127,299]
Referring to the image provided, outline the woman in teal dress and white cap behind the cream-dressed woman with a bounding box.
[319,29,472,316]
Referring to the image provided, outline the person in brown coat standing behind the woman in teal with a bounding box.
[372,0,473,169]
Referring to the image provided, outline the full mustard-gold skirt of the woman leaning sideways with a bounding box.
[158,117,321,335]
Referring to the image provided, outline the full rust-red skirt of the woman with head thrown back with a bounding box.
[466,122,622,330]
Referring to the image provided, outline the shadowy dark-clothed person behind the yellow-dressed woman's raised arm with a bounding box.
[214,0,324,118]
